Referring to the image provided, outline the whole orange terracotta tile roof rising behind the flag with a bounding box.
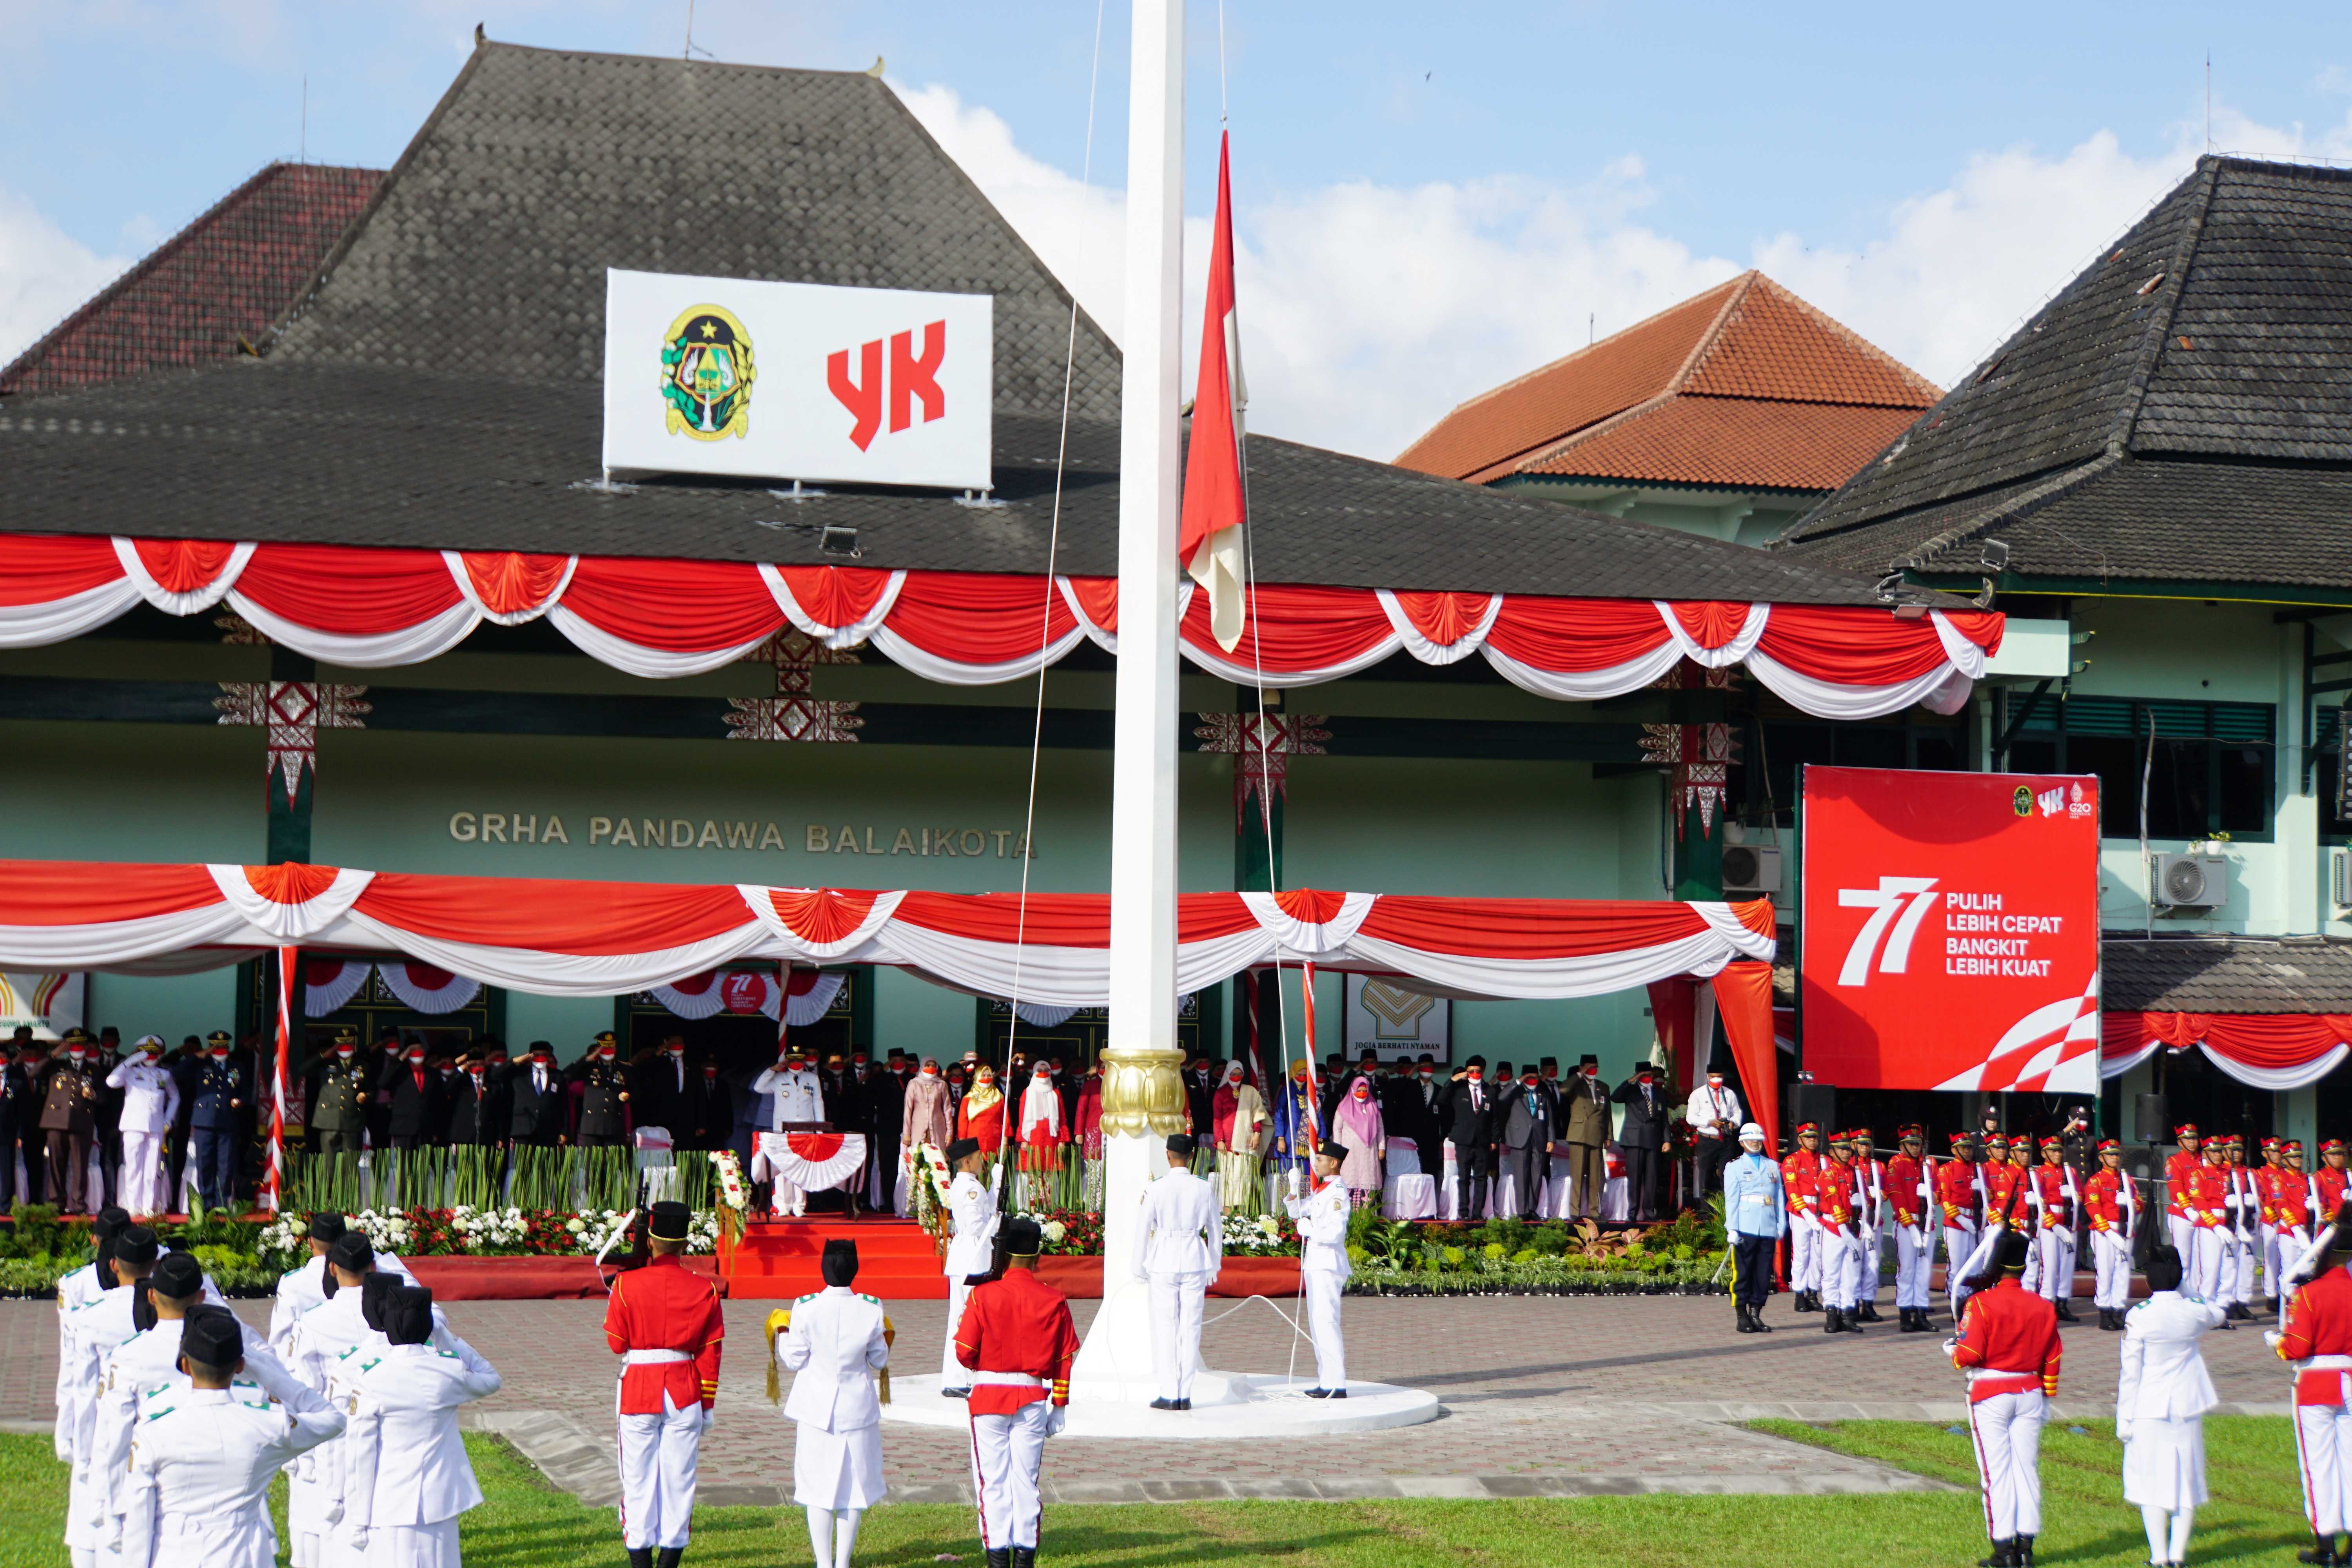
[1397,273,1936,489]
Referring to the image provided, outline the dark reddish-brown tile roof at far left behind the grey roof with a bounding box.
[0,162,383,395]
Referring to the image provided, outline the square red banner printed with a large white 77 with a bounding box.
[1799,766,2098,1093]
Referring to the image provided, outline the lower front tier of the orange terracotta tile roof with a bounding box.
[1512,397,1917,491]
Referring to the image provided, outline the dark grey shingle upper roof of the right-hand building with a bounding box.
[1780,158,2352,588]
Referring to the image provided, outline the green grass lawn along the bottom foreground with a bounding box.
[0,1417,2303,1568]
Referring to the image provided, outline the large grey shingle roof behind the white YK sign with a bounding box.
[0,45,1919,604]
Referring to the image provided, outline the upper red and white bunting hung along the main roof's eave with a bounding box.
[0,534,2002,719]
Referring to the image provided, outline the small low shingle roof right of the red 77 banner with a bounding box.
[2100,936,2352,1013]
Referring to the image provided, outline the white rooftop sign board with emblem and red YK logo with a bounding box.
[604,268,995,489]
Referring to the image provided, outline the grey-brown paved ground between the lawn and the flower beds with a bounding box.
[0,1298,2286,1504]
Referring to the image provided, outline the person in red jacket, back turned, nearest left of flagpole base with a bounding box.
[955,1218,1077,1568]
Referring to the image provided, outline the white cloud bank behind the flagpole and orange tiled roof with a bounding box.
[901,85,2352,458]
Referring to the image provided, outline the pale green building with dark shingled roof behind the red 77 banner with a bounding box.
[1776,155,2352,1140]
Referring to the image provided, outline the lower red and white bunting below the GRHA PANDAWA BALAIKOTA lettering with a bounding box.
[0,860,1773,1006]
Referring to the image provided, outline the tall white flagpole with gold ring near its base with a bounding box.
[1073,0,1185,1401]
